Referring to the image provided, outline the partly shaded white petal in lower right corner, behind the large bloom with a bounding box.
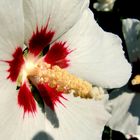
[106,89,140,134]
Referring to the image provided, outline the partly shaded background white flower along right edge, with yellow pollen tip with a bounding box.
[106,19,140,136]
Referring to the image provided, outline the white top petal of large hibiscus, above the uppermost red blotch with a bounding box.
[23,0,89,43]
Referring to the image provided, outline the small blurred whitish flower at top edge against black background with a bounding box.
[93,0,116,12]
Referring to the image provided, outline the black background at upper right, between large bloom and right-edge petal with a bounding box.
[90,0,140,60]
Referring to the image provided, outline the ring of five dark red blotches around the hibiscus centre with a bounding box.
[5,24,71,114]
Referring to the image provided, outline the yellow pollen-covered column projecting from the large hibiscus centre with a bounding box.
[29,62,103,99]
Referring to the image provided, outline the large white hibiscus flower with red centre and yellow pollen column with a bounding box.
[0,0,131,140]
